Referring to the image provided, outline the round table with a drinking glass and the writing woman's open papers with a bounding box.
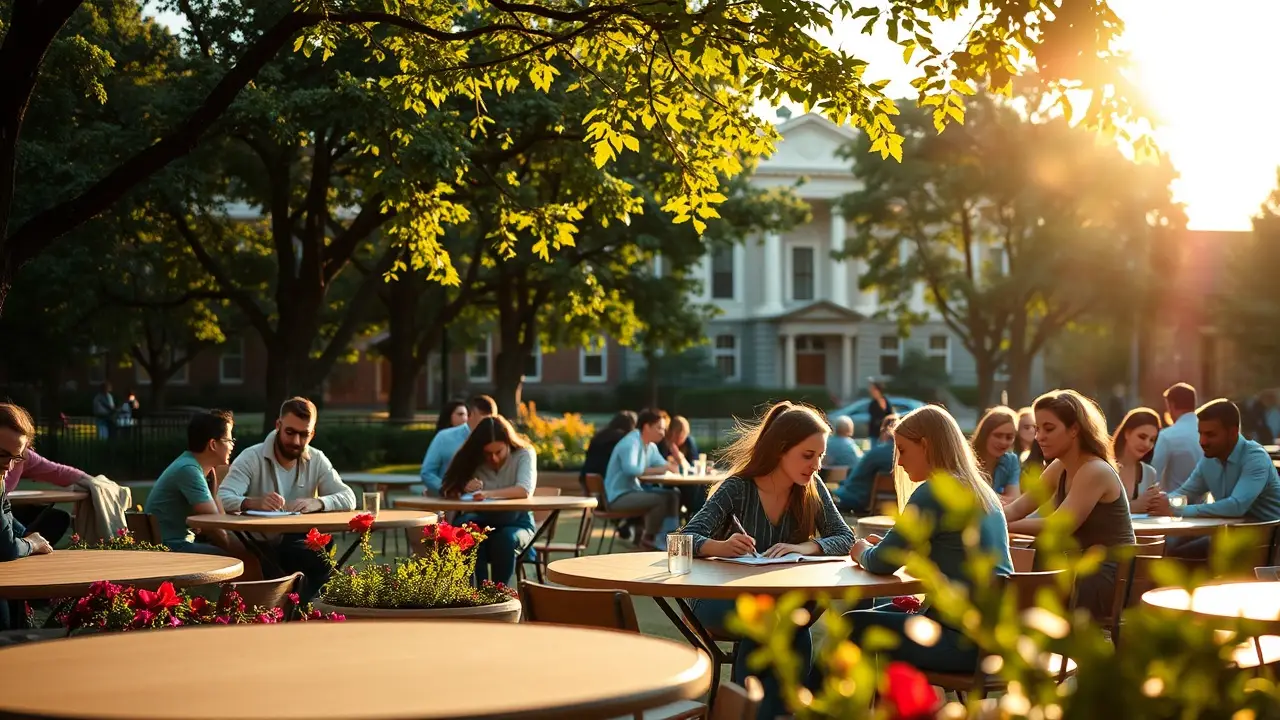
[547,552,924,692]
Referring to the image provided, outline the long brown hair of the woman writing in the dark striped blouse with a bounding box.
[712,400,831,542]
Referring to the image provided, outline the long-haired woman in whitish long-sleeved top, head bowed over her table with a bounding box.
[443,415,538,585]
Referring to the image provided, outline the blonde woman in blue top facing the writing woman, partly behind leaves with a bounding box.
[845,405,1014,673]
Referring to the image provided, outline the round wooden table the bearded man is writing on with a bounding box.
[187,510,436,574]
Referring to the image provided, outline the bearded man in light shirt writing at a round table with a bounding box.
[218,397,356,596]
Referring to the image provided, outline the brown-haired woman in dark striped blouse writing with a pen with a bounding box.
[685,402,854,719]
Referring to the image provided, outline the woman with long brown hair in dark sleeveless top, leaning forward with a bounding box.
[1005,389,1137,618]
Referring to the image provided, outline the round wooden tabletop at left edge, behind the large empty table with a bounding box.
[0,550,244,600]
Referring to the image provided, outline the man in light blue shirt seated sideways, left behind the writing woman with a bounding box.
[604,410,680,548]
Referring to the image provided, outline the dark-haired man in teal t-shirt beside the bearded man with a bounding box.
[146,410,236,555]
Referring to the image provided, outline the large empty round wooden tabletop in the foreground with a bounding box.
[0,621,710,720]
